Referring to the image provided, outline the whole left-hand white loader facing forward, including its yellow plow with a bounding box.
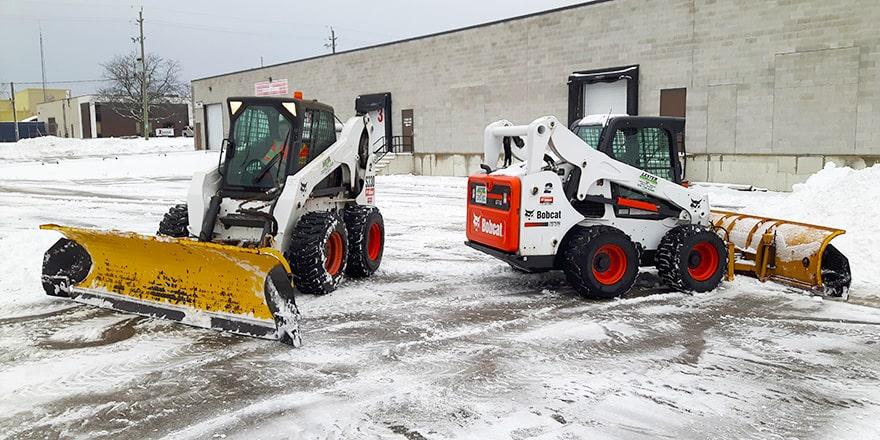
[43,94,390,345]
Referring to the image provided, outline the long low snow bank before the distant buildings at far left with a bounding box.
[0,136,195,161]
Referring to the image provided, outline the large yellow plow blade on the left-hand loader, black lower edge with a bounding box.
[40,225,300,345]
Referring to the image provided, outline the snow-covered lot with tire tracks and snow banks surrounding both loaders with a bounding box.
[0,138,880,439]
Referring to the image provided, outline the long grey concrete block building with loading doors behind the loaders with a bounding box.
[192,0,880,190]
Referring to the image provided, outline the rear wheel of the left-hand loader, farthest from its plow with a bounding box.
[345,205,385,278]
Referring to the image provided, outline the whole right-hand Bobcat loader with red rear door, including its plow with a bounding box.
[466,115,849,298]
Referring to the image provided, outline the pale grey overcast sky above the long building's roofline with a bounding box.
[0,0,583,95]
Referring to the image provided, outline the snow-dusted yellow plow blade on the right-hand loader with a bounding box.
[712,211,852,296]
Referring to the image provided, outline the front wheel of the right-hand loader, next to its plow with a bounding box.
[656,225,727,292]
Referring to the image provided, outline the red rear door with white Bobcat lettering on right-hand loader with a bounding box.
[467,174,520,253]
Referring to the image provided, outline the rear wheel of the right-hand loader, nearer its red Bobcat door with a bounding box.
[562,226,639,299]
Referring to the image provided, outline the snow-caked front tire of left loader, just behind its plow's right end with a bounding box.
[286,211,349,295]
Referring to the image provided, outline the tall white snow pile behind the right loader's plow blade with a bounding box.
[742,163,880,289]
